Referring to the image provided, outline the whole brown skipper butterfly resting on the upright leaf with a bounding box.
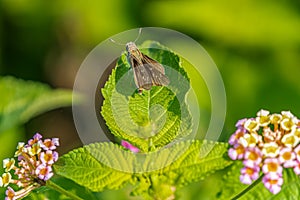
[126,42,170,93]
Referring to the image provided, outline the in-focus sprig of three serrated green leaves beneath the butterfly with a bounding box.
[55,41,231,199]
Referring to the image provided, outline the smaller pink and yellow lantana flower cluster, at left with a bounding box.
[0,133,59,200]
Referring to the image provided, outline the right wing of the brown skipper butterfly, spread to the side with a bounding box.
[142,54,170,86]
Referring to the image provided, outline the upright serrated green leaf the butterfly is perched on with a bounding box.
[101,42,192,152]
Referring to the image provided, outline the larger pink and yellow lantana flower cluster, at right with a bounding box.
[228,110,300,194]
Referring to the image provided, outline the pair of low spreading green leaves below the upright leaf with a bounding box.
[54,141,231,198]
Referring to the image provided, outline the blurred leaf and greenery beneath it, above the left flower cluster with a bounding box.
[0,76,72,199]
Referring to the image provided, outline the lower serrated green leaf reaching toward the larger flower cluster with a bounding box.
[164,140,232,186]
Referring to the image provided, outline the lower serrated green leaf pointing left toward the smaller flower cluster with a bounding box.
[54,143,133,192]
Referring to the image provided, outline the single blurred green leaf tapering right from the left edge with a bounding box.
[0,76,72,133]
